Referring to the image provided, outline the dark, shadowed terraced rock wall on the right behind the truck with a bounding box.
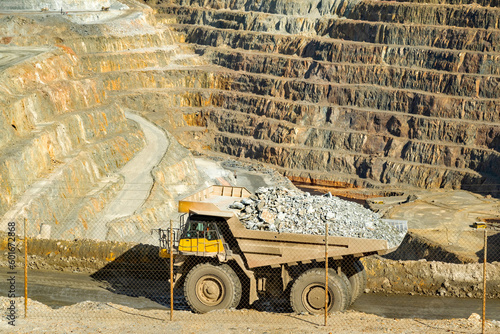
[146,0,500,195]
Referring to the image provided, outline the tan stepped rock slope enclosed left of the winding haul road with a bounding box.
[0,48,144,234]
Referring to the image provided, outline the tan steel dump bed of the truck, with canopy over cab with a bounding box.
[179,186,402,268]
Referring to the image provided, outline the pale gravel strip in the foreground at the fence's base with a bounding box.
[0,297,500,334]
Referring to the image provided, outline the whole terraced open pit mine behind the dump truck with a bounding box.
[0,0,500,302]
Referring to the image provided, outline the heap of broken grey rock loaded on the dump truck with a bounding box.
[229,187,406,248]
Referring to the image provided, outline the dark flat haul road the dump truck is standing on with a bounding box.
[0,268,500,321]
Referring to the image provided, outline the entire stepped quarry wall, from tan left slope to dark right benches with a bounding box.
[0,0,500,237]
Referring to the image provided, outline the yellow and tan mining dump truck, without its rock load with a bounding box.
[157,186,406,313]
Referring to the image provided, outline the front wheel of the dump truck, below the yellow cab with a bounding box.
[184,263,241,313]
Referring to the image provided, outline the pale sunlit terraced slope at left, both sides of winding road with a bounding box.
[0,0,204,242]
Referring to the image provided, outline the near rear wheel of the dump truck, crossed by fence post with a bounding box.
[290,268,349,314]
